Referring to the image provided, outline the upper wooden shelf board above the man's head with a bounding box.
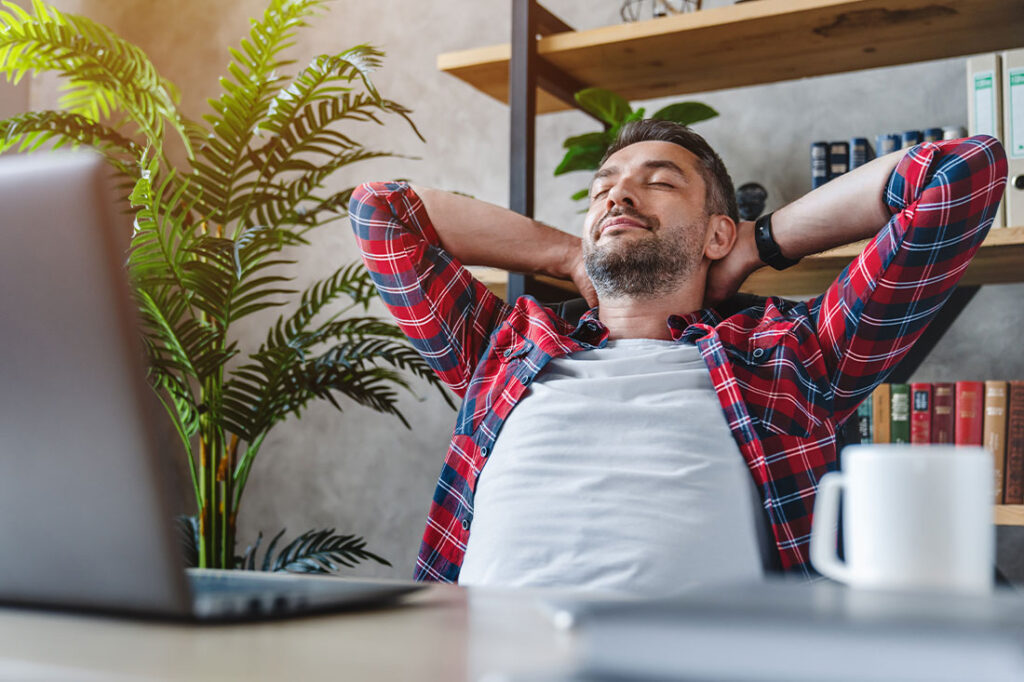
[437,0,1024,114]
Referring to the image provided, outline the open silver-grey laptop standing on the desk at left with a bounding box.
[0,153,422,621]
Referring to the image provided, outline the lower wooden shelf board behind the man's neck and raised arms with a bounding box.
[470,227,1024,298]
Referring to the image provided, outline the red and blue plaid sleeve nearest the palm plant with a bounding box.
[348,182,508,397]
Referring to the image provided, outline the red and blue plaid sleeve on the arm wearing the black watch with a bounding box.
[809,135,1007,423]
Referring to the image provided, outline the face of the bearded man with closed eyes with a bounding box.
[583,141,709,298]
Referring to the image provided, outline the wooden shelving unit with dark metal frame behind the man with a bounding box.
[437,0,1024,525]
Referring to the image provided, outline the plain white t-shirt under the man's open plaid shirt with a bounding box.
[459,339,770,595]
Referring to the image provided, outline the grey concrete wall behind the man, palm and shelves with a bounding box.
[22,0,1024,578]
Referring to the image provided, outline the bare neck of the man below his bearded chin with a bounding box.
[598,279,705,340]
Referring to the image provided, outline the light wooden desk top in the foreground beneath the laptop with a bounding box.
[0,585,572,682]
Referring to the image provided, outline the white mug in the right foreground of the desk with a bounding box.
[811,443,995,593]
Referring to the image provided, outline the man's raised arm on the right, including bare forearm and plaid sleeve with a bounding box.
[709,135,1007,423]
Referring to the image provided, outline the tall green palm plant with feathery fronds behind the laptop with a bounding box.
[0,0,452,570]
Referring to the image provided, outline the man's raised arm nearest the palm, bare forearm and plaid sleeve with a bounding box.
[349,182,593,396]
